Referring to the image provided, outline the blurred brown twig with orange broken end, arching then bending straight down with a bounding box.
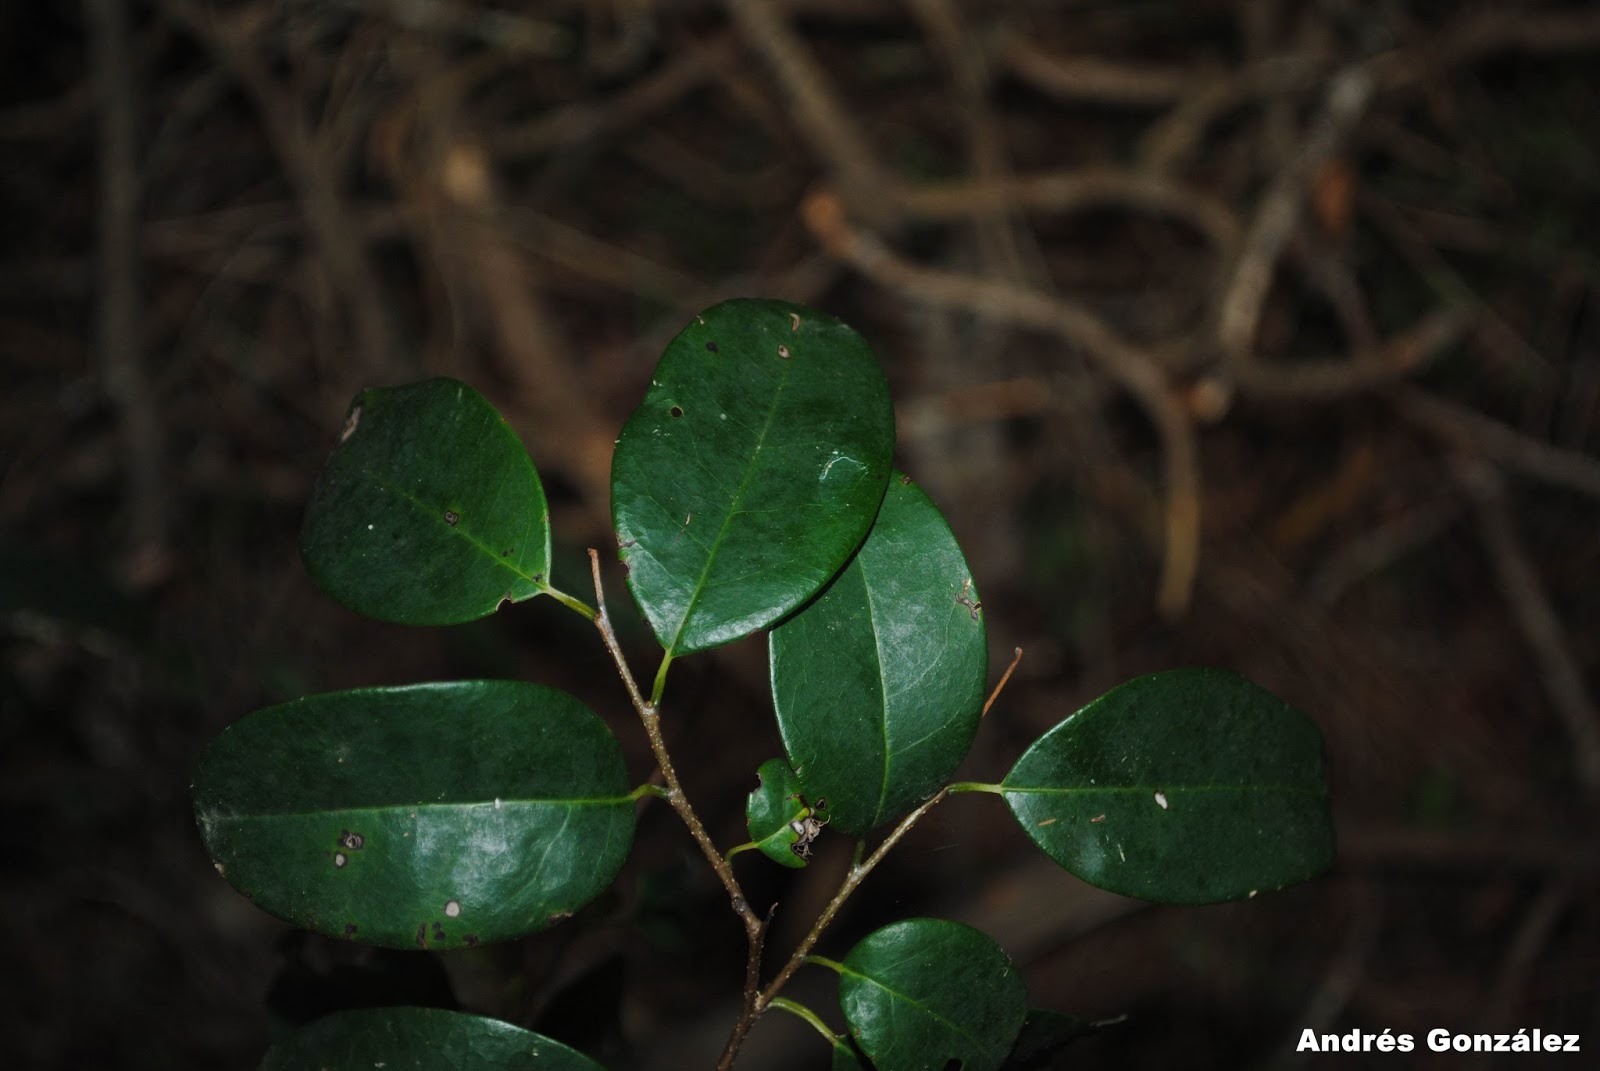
[802,192,1200,618]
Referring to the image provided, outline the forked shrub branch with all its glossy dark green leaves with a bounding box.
[194,299,1333,1071]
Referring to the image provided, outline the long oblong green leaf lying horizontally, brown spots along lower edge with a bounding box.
[194,680,634,948]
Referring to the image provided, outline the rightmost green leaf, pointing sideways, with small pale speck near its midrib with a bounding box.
[1002,669,1333,903]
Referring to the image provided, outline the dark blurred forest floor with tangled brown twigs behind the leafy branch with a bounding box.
[0,0,1600,1068]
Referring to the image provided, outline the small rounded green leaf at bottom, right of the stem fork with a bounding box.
[838,919,1027,1071]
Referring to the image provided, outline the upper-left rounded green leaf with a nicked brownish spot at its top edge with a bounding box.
[301,379,550,624]
